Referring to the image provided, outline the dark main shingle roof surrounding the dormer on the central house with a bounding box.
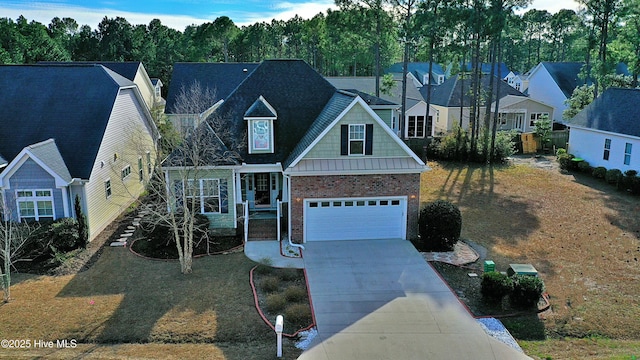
[212,60,336,164]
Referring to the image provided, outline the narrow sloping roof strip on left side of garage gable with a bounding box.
[283,91,356,169]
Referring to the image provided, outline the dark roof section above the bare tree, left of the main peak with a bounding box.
[165,63,259,114]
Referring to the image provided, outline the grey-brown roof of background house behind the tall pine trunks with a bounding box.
[420,75,525,107]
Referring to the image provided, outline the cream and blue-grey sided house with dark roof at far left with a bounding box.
[0,64,157,240]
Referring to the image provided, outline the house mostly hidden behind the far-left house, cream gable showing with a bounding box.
[38,61,158,110]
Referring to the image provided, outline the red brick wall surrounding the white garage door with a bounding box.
[291,174,420,243]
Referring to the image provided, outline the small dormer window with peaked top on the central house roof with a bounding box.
[244,96,278,154]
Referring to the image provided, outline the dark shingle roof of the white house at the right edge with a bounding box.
[564,88,640,137]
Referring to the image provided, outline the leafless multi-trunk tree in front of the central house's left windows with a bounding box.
[144,83,246,274]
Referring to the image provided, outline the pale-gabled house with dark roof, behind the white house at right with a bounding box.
[522,61,629,122]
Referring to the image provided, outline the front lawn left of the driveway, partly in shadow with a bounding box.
[0,247,300,359]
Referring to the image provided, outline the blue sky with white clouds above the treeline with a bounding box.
[0,0,578,31]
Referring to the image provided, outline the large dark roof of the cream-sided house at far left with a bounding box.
[0,64,135,179]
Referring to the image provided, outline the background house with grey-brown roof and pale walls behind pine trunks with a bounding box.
[422,75,532,135]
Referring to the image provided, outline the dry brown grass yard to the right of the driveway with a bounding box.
[421,163,640,359]
